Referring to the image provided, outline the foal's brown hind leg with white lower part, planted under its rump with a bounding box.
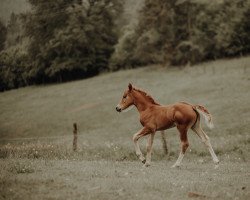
[172,125,189,167]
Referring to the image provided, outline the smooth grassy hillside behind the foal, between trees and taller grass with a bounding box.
[0,57,250,158]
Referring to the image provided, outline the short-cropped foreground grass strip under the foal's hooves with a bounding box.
[0,159,250,200]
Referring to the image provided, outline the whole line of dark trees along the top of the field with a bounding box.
[0,0,250,91]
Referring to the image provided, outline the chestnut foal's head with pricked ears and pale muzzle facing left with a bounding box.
[116,83,134,112]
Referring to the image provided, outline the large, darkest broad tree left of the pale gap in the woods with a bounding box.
[26,0,122,83]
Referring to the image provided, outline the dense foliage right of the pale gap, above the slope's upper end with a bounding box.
[111,0,250,69]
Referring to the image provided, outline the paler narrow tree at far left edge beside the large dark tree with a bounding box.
[0,13,28,91]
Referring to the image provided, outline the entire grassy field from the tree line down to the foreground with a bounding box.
[0,57,250,200]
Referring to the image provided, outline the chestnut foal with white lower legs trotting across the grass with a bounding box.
[116,84,219,167]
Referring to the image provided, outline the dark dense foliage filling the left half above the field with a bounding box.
[0,0,122,90]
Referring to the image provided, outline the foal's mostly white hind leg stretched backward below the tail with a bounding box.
[192,121,219,164]
